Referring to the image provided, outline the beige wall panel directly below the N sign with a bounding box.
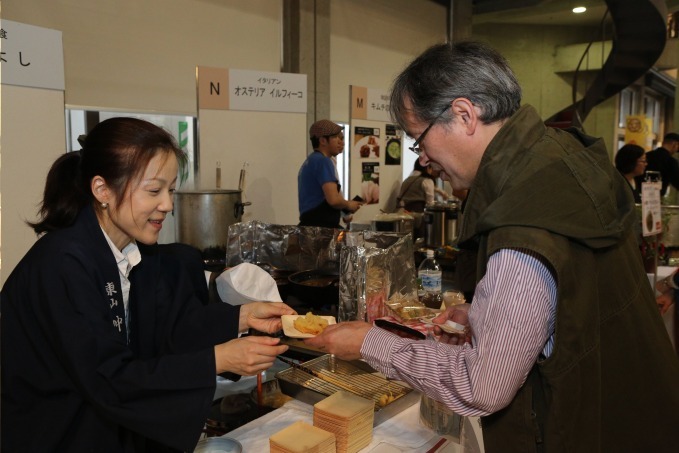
[199,109,308,225]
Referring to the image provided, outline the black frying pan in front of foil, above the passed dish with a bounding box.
[288,269,339,307]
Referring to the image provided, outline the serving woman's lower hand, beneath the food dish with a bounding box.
[215,335,288,376]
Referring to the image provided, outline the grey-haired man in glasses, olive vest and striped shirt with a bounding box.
[305,41,679,453]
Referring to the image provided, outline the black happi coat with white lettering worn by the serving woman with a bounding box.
[1,208,238,453]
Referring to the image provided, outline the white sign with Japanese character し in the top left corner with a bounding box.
[0,19,65,91]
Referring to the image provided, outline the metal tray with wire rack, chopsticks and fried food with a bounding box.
[276,354,420,426]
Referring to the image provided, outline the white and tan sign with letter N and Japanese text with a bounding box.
[196,66,307,113]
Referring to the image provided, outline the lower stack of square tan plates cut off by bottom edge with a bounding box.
[269,421,339,453]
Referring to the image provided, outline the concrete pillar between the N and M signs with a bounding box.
[281,0,330,153]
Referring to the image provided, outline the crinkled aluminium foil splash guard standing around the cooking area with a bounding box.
[226,220,417,322]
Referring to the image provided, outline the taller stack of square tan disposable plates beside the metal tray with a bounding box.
[314,391,375,453]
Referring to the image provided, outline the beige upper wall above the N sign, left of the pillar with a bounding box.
[2,0,281,115]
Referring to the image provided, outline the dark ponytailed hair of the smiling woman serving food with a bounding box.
[27,117,186,234]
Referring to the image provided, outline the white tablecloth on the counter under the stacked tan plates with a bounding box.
[224,400,483,453]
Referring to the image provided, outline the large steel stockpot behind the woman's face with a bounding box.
[174,189,250,268]
